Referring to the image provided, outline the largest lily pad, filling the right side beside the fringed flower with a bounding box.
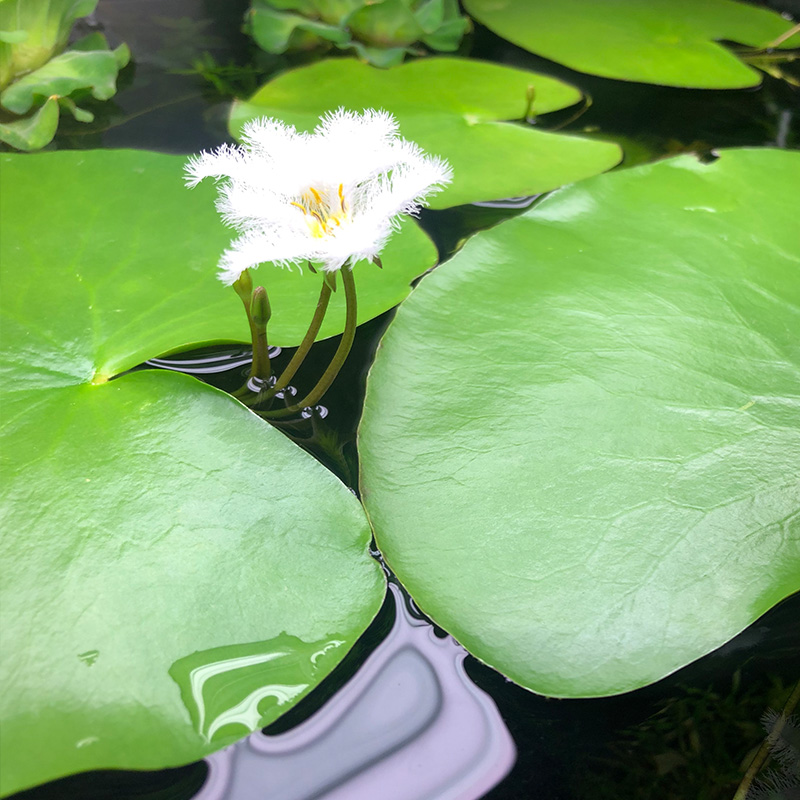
[360,150,800,697]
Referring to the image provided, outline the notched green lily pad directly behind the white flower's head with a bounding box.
[230,58,622,208]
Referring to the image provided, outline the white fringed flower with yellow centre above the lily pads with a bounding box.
[186,109,452,284]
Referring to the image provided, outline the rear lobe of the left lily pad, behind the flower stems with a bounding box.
[0,150,436,362]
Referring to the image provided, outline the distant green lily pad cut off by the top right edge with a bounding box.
[464,0,800,89]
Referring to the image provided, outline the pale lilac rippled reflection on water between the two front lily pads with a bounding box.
[195,584,516,800]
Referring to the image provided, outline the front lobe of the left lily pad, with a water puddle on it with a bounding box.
[0,372,383,794]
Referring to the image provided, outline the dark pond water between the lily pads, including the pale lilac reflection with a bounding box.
[10,0,800,800]
